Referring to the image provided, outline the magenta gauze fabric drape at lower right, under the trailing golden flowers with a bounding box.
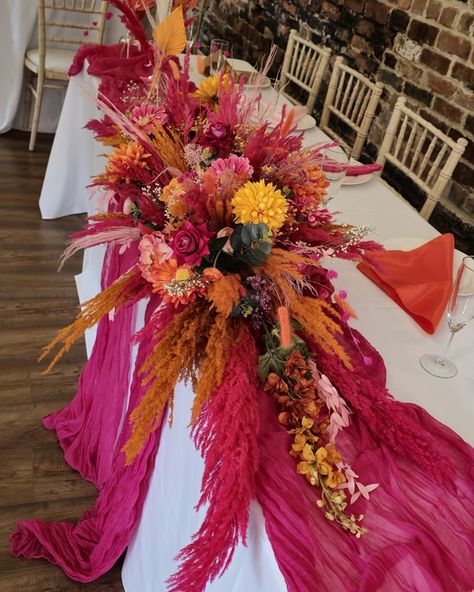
[257,336,474,592]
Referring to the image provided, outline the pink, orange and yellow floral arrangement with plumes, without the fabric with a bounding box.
[39,8,396,591]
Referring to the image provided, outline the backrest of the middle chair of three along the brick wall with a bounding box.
[319,56,384,159]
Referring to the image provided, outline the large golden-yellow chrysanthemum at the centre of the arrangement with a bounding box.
[232,181,288,232]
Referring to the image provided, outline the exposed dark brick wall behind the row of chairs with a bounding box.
[202,0,474,222]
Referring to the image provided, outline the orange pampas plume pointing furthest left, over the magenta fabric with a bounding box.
[38,267,145,374]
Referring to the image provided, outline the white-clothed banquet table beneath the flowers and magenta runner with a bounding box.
[35,56,474,592]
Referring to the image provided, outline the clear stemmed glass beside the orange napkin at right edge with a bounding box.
[420,255,474,378]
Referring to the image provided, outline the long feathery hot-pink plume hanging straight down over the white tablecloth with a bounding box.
[168,334,259,592]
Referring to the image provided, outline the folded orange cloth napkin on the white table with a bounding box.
[357,234,454,334]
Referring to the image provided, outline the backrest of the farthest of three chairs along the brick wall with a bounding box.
[280,29,331,113]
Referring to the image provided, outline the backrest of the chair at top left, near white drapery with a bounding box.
[38,0,108,54]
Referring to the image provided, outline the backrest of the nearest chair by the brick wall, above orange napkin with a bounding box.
[377,97,467,220]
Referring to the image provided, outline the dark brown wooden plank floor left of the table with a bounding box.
[0,132,123,592]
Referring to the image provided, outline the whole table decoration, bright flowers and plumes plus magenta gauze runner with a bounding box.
[12,0,473,592]
